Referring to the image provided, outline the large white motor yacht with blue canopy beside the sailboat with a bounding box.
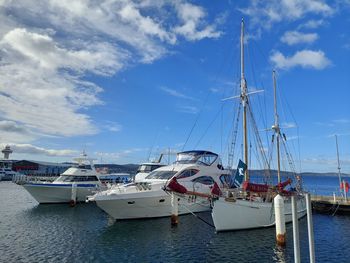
[88,151,229,220]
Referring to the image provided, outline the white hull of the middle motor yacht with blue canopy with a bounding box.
[94,190,211,220]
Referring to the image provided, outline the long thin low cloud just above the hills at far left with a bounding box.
[1,143,78,156]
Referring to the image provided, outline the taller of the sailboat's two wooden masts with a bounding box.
[241,19,249,181]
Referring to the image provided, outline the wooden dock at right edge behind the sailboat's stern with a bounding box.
[311,195,350,215]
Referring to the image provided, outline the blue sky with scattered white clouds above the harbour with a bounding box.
[0,0,350,173]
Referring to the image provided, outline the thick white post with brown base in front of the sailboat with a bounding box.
[274,194,286,246]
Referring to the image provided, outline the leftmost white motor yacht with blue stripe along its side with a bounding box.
[19,154,102,204]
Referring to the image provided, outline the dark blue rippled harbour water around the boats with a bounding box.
[0,178,350,262]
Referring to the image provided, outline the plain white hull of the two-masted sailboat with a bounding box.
[212,197,306,231]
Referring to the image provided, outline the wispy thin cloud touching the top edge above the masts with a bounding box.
[239,0,335,29]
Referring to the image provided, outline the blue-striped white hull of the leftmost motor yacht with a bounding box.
[23,183,98,204]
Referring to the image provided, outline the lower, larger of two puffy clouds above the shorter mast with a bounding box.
[270,50,331,70]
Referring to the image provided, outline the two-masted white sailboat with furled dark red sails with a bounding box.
[212,20,306,231]
